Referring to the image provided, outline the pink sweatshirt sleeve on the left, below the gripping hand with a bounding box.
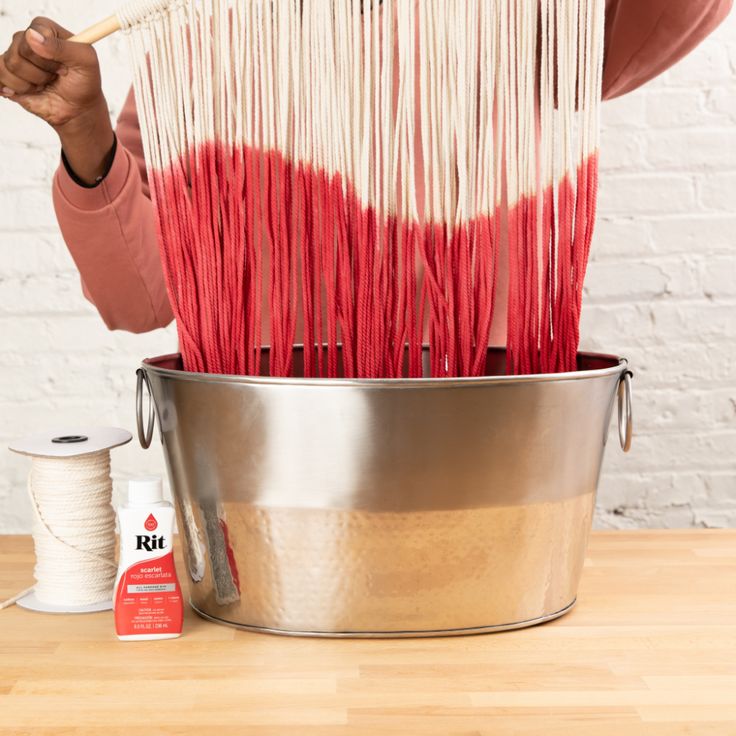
[53,86,173,332]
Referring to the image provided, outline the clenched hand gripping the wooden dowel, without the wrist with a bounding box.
[0,18,106,128]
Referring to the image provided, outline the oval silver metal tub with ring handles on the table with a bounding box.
[137,349,631,636]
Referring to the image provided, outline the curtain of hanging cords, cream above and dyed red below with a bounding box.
[119,0,605,378]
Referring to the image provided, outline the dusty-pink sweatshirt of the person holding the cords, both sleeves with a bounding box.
[54,0,733,332]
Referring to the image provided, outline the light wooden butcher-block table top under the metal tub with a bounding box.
[0,530,736,736]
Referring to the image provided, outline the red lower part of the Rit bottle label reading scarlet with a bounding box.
[115,547,184,636]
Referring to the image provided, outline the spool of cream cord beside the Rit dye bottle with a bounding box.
[0,427,132,613]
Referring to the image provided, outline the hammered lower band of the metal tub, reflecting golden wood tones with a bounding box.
[190,493,594,633]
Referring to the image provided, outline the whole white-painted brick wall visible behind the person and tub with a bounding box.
[0,0,736,532]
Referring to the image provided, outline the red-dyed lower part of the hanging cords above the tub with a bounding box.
[152,144,597,378]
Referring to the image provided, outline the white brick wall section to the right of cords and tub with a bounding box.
[583,14,736,527]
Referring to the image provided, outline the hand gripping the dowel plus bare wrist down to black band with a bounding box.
[0,18,115,184]
